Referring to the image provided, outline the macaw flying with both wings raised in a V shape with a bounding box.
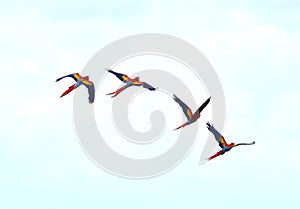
[173,94,210,131]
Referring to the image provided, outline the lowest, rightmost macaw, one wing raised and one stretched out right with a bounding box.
[206,122,255,160]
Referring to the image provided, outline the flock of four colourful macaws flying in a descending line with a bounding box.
[56,69,255,162]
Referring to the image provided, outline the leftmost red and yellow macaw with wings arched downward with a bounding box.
[56,73,95,104]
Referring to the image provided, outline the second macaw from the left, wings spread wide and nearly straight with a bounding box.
[106,69,156,98]
